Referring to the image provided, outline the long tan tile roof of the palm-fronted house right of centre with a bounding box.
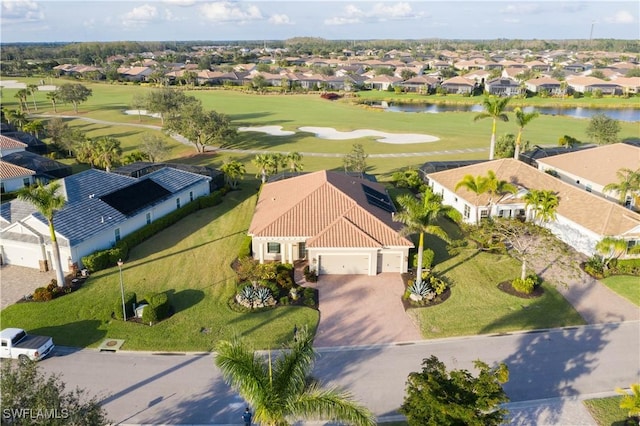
[428,158,640,240]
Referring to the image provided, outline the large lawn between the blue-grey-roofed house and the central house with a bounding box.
[2,182,319,351]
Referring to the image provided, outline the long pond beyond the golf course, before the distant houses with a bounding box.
[372,102,640,122]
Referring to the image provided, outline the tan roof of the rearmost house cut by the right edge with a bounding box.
[538,143,640,185]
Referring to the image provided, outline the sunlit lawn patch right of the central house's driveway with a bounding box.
[410,245,584,339]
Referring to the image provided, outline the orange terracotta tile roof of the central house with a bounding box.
[248,171,413,247]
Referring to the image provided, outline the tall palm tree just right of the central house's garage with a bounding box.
[393,186,460,285]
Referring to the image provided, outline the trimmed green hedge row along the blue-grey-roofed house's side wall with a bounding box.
[82,191,222,272]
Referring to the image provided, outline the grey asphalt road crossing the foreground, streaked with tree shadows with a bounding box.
[36,321,640,425]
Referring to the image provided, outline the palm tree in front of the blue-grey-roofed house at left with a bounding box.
[18,181,67,287]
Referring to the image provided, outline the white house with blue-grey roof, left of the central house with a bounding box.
[0,167,210,272]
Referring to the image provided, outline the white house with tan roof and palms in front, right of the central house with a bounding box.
[427,157,640,256]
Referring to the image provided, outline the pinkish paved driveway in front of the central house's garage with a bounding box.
[306,273,422,347]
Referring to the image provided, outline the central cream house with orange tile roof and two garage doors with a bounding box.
[248,170,413,275]
